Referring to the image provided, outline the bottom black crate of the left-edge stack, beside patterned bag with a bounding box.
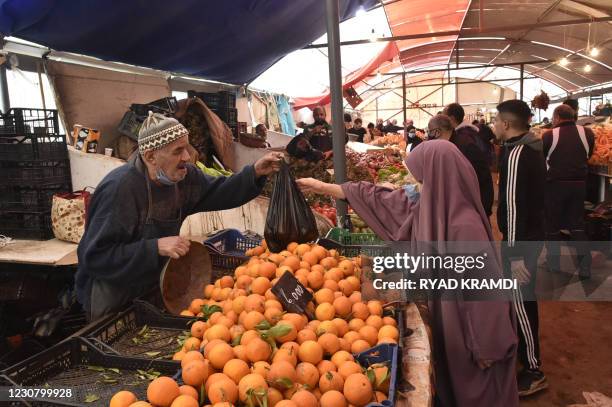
[0,211,53,240]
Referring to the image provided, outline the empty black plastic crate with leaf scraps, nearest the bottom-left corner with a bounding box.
[3,338,177,407]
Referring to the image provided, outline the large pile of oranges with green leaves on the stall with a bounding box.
[110,241,399,407]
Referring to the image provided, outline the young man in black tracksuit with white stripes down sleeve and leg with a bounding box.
[495,100,548,396]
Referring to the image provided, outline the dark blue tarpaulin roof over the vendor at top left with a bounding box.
[0,0,377,85]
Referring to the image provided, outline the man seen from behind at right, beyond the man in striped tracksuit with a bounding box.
[542,104,595,279]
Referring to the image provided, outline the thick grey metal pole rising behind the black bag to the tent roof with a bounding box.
[325,0,347,226]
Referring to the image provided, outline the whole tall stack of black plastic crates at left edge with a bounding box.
[0,108,72,239]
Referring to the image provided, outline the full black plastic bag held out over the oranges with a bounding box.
[264,163,319,253]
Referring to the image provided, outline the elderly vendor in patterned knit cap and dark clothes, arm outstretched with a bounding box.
[76,113,282,320]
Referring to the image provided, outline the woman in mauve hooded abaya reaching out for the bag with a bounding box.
[298,140,518,407]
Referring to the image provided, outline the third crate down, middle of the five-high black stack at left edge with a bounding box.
[0,160,71,187]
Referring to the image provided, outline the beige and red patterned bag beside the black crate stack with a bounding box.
[51,190,91,243]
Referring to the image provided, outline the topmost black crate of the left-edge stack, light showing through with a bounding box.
[0,108,59,135]
